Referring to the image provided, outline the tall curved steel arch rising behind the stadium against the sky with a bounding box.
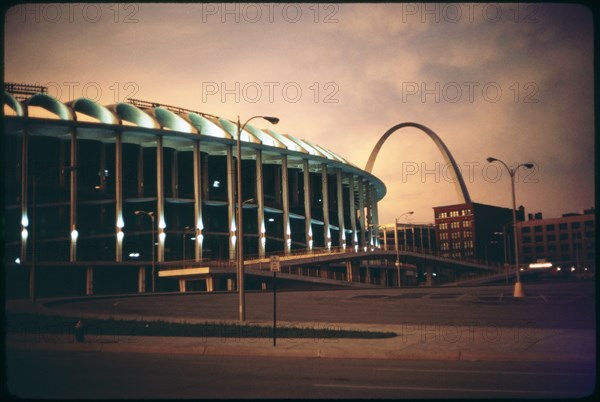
[365,122,471,203]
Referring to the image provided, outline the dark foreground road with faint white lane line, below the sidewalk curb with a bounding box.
[7,350,595,399]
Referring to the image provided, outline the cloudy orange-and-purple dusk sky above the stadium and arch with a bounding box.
[4,3,595,223]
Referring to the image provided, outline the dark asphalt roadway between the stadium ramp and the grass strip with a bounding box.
[53,282,596,329]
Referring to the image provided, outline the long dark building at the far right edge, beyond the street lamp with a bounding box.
[517,208,596,273]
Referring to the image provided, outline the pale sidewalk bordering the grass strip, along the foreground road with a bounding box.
[6,302,596,361]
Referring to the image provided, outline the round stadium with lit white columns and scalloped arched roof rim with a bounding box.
[4,84,386,296]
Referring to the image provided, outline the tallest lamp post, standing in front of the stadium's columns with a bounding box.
[236,116,279,321]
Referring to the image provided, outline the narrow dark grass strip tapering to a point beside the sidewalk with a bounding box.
[6,313,397,339]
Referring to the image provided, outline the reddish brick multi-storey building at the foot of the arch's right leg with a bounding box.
[433,202,525,263]
